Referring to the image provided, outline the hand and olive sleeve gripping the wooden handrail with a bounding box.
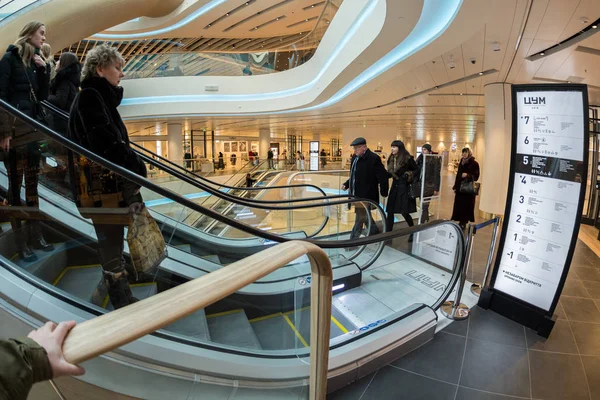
[0,321,85,399]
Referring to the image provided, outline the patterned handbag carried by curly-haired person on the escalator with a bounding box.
[127,207,167,273]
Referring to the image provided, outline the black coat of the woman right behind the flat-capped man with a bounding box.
[386,154,417,214]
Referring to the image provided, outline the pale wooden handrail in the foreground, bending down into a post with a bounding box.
[63,241,333,400]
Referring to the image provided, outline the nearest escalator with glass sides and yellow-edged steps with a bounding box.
[0,99,464,399]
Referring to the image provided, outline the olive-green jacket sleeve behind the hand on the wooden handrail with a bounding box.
[0,338,52,400]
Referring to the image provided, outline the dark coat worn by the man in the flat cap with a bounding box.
[344,149,389,203]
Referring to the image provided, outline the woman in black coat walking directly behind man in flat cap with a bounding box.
[385,140,417,232]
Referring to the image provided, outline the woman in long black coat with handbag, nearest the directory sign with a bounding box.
[452,147,479,230]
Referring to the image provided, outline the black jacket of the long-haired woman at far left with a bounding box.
[0,44,50,139]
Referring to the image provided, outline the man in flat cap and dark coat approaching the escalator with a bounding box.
[342,137,389,239]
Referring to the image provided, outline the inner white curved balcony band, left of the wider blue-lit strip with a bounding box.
[122,0,384,114]
